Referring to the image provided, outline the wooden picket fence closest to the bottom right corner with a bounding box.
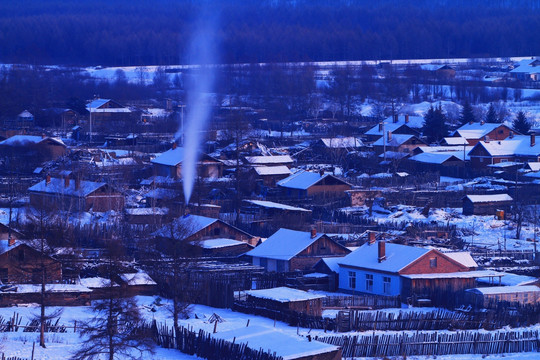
[315,330,540,358]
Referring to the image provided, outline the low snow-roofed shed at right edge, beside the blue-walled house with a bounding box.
[465,285,540,308]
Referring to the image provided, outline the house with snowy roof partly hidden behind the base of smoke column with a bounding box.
[151,143,223,179]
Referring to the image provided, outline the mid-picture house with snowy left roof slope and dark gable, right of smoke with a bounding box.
[277,170,352,199]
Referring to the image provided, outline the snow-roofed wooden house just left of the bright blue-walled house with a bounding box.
[246,229,350,272]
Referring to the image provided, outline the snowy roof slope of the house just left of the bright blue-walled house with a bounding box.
[246,228,324,260]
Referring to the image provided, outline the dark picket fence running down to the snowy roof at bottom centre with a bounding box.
[148,320,283,360]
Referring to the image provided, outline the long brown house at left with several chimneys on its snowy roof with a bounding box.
[28,175,124,212]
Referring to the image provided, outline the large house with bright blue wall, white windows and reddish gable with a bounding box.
[339,241,488,300]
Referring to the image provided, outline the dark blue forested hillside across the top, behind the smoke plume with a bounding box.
[0,0,540,65]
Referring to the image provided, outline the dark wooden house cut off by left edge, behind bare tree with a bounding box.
[0,240,62,284]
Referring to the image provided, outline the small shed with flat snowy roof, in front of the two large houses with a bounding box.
[246,287,325,316]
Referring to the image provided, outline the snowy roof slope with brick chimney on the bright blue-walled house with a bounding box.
[339,243,430,273]
